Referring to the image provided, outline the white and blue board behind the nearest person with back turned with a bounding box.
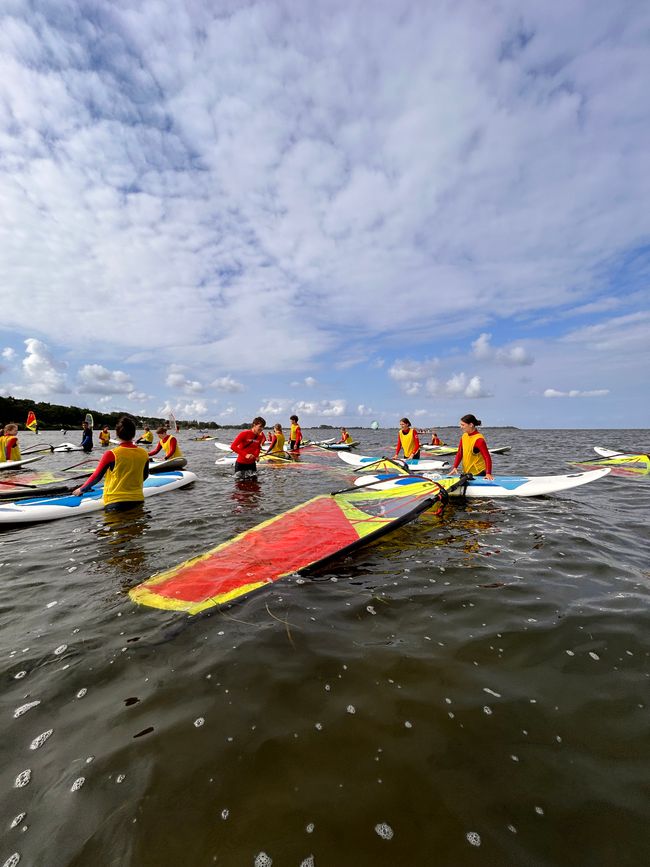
[0,470,196,525]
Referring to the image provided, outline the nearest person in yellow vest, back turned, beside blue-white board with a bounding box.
[73,415,149,512]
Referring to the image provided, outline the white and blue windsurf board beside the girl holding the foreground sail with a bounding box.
[354,468,610,497]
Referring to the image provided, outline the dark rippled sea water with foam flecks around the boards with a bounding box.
[0,428,650,867]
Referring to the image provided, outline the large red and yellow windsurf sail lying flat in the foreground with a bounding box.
[129,478,458,614]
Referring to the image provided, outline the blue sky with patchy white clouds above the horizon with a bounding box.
[0,0,650,428]
